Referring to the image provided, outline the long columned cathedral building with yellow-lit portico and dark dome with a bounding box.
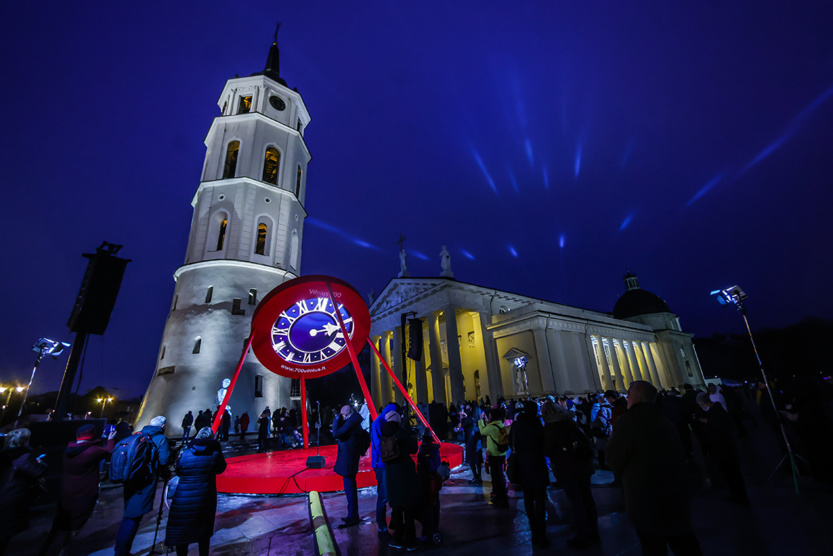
[370,274,704,404]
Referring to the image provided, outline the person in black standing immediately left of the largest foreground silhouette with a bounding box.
[541,401,600,548]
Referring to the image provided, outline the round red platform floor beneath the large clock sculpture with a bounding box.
[217,444,463,494]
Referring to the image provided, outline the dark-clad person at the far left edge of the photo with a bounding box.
[0,429,46,554]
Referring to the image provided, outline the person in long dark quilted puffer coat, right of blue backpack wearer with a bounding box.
[165,427,226,556]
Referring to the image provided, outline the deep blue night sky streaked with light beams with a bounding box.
[0,0,833,398]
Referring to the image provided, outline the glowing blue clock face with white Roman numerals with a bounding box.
[272,297,353,365]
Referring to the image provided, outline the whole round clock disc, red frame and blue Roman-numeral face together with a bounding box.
[252,276,370,378]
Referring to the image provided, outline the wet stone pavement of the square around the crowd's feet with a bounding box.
[7,414,833,556]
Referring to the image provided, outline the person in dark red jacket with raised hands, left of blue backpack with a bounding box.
[40,425,116,555]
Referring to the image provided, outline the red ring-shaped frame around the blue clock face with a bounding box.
[252,275,370,378]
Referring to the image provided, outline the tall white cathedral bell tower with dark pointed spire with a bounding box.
[136,33,311,436]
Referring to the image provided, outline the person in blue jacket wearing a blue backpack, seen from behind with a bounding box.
[115,415,171,556]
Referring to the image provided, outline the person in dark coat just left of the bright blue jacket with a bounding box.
[333,405,364,529]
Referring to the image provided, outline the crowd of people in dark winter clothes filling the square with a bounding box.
[0,381,833,556]
